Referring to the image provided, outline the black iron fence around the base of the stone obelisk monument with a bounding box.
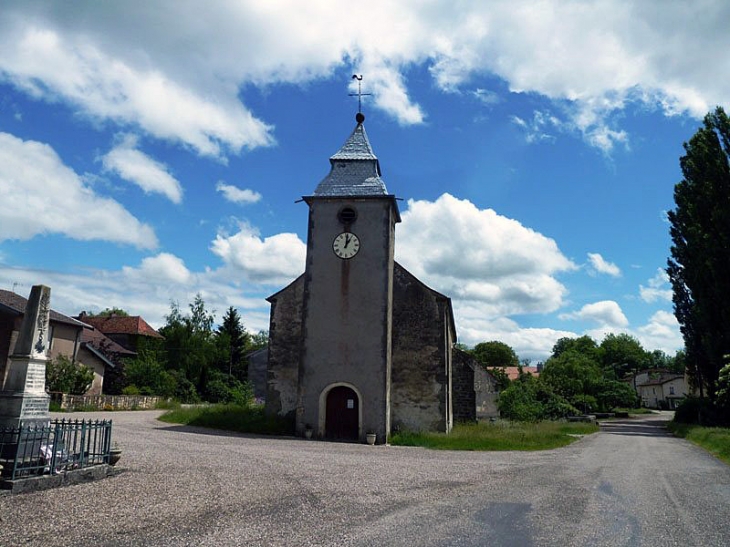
[0,419,112,480]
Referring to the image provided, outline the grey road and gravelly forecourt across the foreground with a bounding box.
[0,412,730,547]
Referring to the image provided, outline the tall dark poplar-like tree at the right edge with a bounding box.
[667,107,730,399]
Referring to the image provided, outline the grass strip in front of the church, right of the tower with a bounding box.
[390,421,598,450]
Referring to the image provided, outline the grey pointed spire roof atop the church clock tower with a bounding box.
[314,113,389,197]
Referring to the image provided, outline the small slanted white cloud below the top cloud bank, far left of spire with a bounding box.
[102,135,182,204]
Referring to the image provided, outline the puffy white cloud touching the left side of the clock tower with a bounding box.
[211,224,306,285]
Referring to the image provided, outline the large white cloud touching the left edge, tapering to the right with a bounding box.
[0,133,157,249]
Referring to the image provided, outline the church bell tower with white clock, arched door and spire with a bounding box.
[296,113,400,443]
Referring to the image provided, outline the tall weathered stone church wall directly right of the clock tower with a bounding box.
[390,264,451,431]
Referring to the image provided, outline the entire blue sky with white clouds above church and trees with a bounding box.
[0,0,730,360]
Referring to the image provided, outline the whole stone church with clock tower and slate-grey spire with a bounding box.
[265,113,496,444]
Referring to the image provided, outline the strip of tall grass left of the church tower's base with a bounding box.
[159,405,294,435]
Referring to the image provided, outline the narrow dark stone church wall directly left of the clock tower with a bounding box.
[266,276,304,418]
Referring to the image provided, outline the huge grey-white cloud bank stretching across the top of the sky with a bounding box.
[0,0,730,157]
